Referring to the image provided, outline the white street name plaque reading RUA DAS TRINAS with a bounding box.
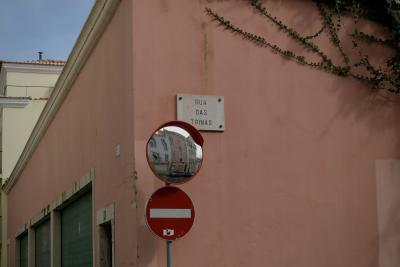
[176,94,225,132]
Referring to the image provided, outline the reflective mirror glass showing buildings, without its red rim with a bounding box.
[148,127,202,183]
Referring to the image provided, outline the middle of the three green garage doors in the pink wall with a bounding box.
[35,220,50,267]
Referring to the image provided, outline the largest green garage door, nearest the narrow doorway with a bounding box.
[61,192,93,267]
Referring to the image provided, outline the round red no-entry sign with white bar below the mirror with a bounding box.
[146,186,194,240]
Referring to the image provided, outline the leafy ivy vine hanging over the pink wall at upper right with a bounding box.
[205,0,400,94]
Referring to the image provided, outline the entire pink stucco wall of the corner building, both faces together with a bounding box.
[8,0,400,267]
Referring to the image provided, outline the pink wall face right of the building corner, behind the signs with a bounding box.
[133,0,400,267]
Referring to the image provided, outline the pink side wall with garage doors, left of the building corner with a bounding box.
[8,1,136,266]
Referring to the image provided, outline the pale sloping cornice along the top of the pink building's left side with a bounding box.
[2,0,120,194]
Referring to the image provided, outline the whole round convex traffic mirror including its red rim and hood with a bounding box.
[146,121,203,184]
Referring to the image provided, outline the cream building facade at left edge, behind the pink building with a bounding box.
[0,60,64,266]
